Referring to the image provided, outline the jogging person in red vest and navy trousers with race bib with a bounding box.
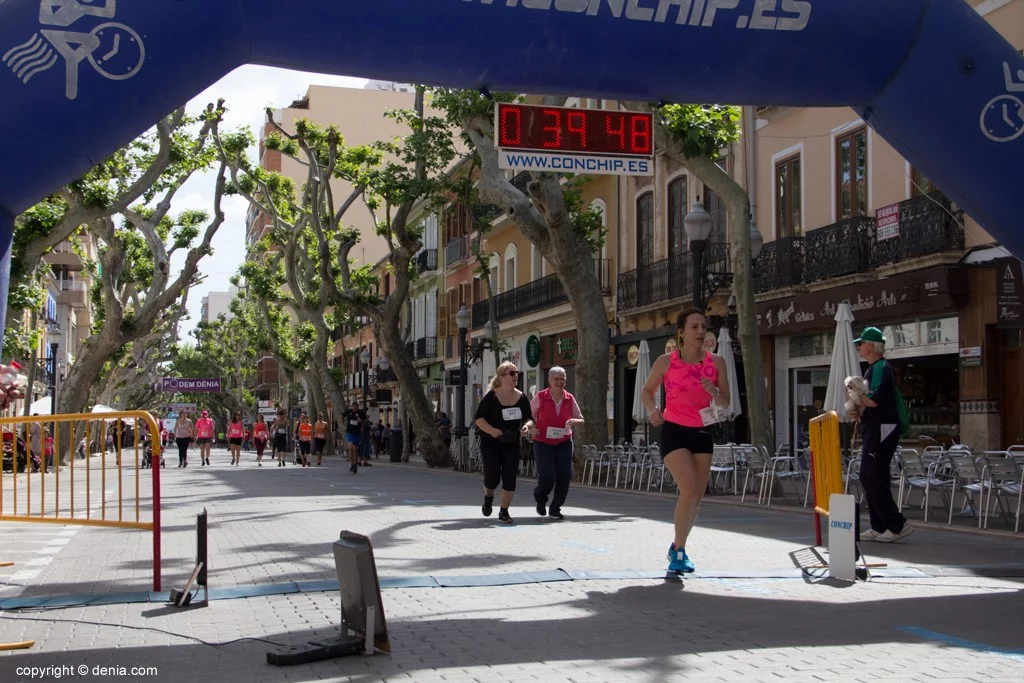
[529,366,583,519]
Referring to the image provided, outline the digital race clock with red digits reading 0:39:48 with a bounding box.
[495,102,652,157]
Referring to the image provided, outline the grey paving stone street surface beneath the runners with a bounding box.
[0,451,1024,683]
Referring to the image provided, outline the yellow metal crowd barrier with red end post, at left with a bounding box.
[0,411,161,591]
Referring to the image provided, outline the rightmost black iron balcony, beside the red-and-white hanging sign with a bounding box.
[870,190,964,268]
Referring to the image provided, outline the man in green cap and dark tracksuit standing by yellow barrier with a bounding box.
[852,328,913,543]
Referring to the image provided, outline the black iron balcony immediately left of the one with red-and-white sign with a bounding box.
[802,216,874,284]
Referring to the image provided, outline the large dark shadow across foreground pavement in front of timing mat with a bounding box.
[0,584,1024,681]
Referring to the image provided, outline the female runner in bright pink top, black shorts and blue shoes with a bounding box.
[641,308,729,573]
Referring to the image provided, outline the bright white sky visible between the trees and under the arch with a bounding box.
[171,65,367,343]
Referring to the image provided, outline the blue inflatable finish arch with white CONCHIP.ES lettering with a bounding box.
[0,0,1024,348]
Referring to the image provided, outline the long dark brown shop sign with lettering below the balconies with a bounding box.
[758,266,968,335]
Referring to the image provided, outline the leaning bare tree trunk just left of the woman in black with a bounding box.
[374,317,452,467]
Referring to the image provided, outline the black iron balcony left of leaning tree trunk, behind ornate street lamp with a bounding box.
[615,242,732,311]
